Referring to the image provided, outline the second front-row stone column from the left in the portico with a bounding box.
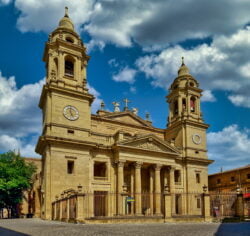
[135,162,142,215]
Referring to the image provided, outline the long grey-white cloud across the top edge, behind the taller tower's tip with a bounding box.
[1,0,250,50]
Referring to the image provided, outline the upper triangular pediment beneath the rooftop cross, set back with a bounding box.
[103,111,152,127]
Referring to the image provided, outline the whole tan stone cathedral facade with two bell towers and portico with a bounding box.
[36,8,212,220]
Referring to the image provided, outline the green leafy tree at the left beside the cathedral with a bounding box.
[0,151,36,217]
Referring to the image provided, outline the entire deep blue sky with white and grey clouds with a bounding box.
[0,0,250,173]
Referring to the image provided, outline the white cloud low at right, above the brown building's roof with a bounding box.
[207,125,250,172]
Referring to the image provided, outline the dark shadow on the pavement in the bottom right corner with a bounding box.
[214,222,250,236]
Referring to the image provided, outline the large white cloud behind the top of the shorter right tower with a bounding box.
[136,27,250,107]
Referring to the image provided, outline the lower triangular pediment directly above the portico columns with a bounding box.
[117,134,180,155]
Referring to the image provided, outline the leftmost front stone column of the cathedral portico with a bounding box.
[117,160,125,215]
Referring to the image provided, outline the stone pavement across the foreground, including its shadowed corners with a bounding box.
[0,219,250,236]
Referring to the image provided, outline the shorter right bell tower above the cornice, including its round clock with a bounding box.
[165,58,209,158]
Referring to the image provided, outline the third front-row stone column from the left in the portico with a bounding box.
[155,164,162,215]
